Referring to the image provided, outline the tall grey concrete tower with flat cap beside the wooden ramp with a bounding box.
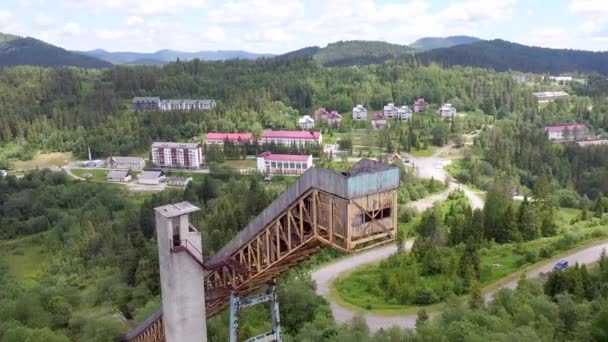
[154,202,207,342]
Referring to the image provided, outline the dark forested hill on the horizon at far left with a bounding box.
[0,33,112,69]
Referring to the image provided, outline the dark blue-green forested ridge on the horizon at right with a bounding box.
[416,39,608,75]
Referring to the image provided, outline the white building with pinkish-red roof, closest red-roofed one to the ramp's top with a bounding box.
[257,152,312,175]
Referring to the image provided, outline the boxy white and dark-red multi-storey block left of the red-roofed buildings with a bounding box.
[152,142,203,169]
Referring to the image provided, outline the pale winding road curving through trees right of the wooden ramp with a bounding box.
[311,146,608,331]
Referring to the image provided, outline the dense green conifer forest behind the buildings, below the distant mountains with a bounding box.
[0,59,536,160]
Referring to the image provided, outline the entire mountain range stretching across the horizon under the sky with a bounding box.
[0,33,608,75]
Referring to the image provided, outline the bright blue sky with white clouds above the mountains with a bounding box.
[0,0,608,53]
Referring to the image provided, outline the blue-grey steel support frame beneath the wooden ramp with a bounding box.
[230,283,282,342]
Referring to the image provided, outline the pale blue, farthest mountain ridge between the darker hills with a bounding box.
[73,49,273,64]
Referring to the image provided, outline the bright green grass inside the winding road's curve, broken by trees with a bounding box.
[331,204,608,315]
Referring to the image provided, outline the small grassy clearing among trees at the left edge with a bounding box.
[0,233,48,287]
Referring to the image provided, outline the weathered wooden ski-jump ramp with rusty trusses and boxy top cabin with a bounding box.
[123,160,399,342]
